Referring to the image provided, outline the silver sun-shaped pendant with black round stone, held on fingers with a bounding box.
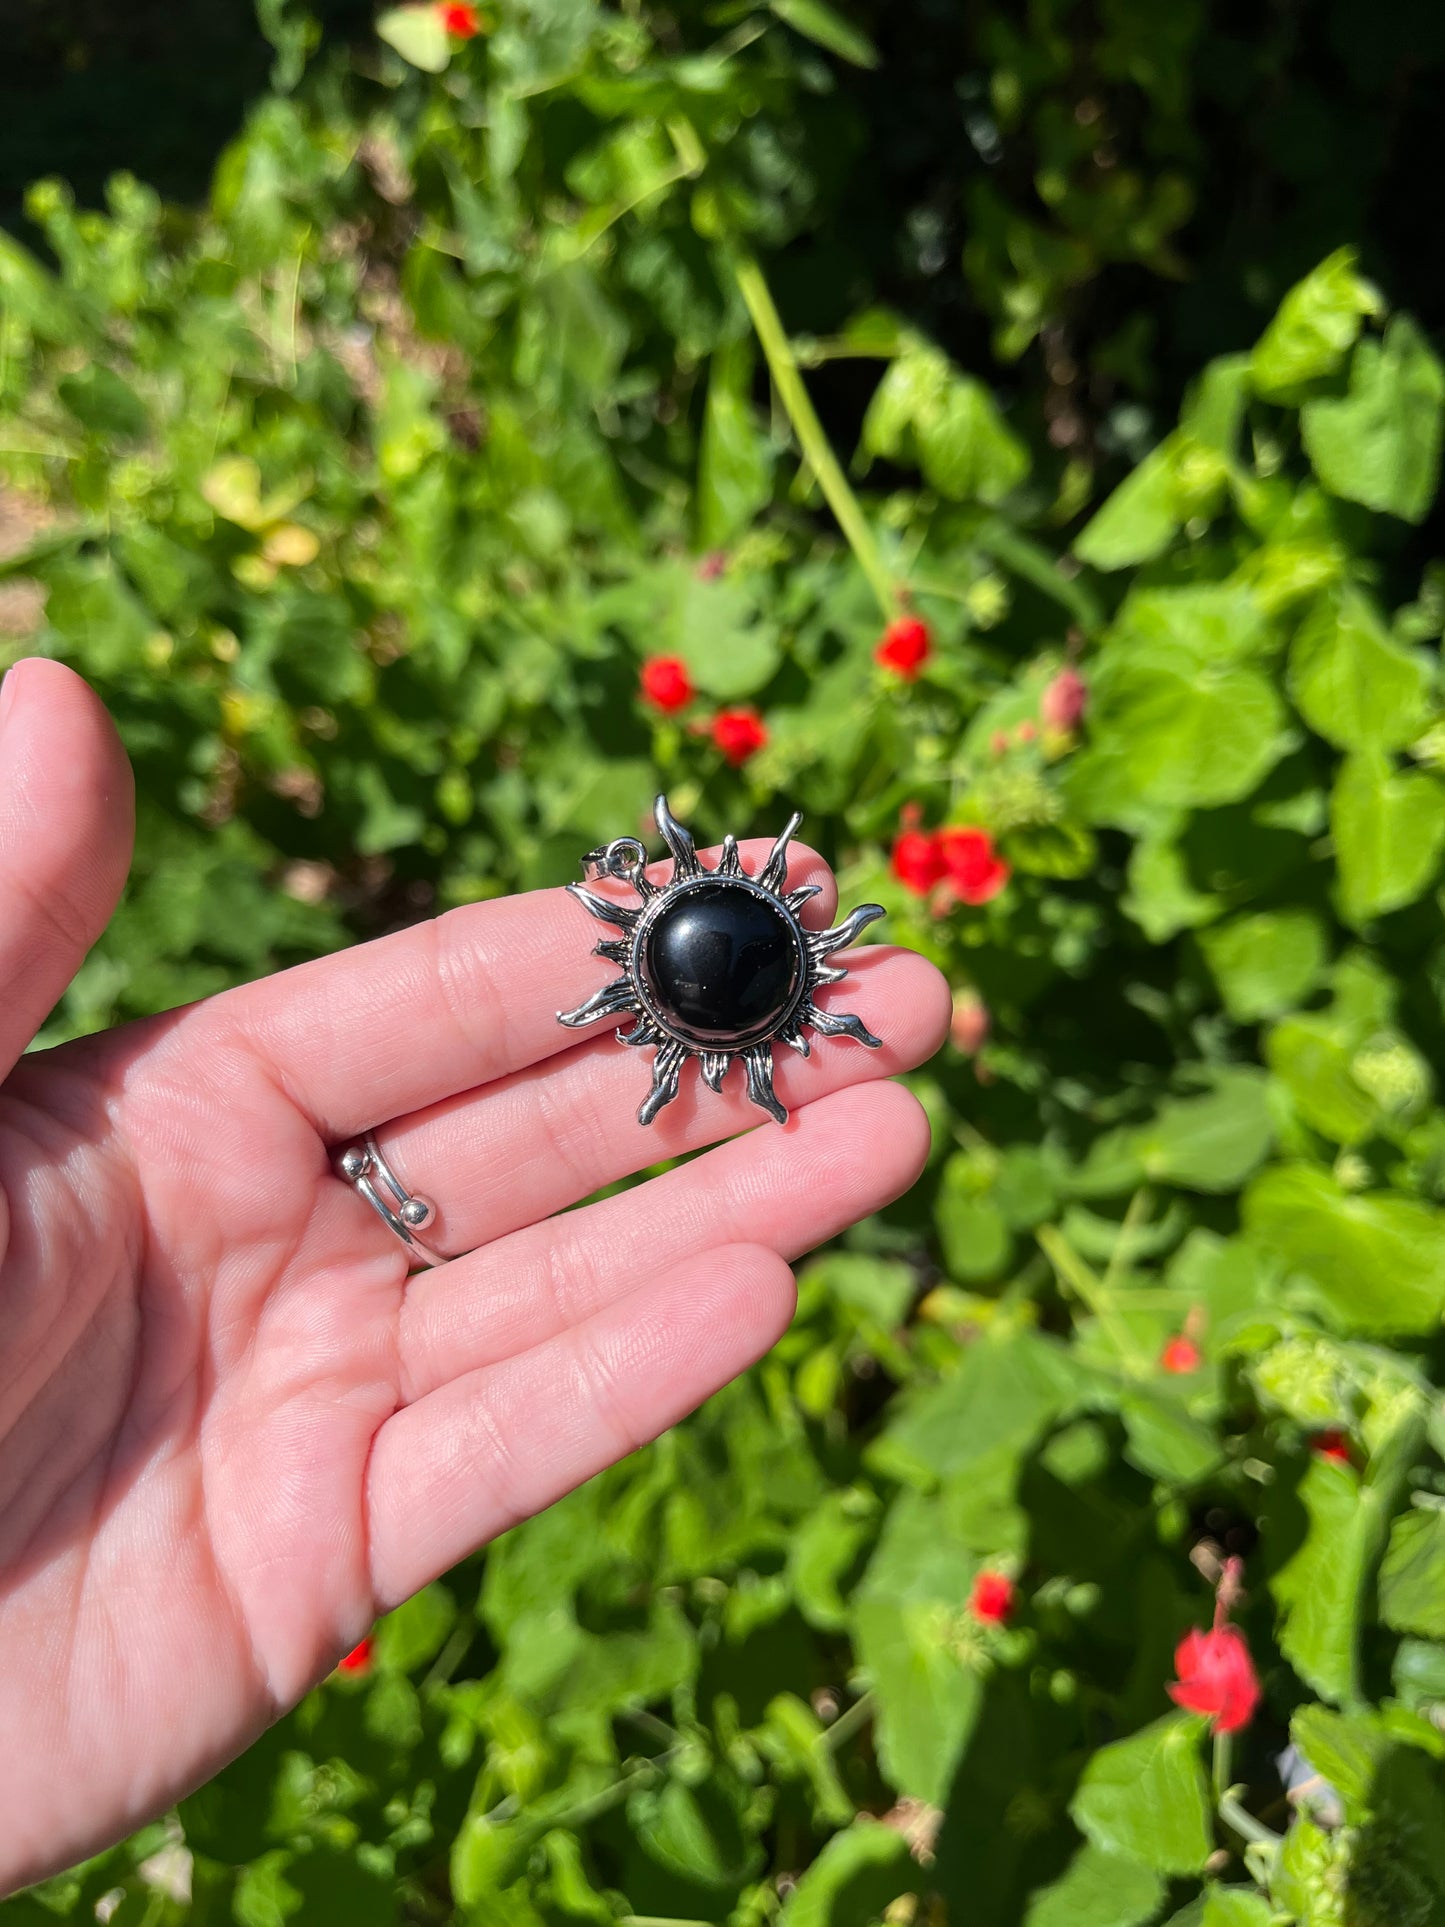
[557,796,882,1123]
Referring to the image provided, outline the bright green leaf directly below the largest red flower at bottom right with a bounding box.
[1069,1713,1214,1873]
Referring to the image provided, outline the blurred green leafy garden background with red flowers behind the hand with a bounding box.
[0,0,1445,1927]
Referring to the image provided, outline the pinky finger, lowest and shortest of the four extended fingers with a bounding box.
[364,1245,794,1611]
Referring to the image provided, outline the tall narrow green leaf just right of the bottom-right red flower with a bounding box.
[1270,1453,1378,1700]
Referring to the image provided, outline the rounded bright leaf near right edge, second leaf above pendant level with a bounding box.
[1289,590,1430,750]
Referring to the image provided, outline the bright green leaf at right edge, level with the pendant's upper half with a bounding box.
[1329,752,1445,929]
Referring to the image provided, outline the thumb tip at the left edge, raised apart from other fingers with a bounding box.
[0,657,135,1077]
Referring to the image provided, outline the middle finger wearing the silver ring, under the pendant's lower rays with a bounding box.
[360,944,952,1253]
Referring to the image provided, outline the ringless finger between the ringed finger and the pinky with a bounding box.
[401,1083,929,1403]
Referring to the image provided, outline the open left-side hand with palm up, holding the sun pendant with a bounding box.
[0,661,948,1890]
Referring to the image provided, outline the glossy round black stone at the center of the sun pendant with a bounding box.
[642,877,803,1046]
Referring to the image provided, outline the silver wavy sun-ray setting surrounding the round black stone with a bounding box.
[557,796,882,1123]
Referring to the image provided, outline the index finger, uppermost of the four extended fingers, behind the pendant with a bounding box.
[210,842,838,1143]
